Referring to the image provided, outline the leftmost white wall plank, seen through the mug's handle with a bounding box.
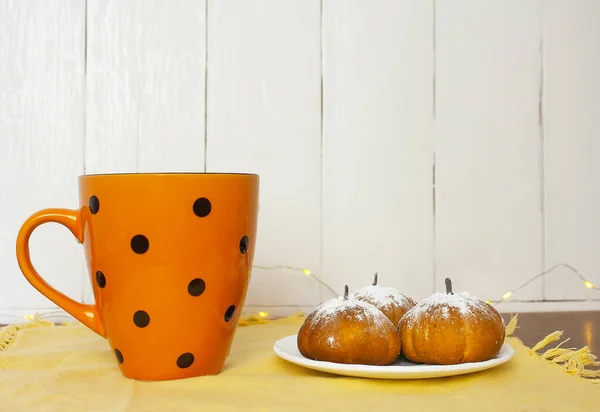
[0,0,87,316]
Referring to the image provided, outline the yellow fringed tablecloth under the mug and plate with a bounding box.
[0,318,600,412]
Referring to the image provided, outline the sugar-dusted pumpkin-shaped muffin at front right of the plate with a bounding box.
[398,278,505,365]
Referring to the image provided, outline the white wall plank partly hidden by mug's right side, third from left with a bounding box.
[206,0,321,306]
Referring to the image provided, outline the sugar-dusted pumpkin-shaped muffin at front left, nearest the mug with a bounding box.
[298,286,401,365]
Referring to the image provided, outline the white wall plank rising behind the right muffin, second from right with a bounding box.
[435,0,543,299]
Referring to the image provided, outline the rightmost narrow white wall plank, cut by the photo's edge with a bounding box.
[543,0,600,300]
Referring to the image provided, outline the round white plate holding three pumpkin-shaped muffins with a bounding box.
[273,335,515,379]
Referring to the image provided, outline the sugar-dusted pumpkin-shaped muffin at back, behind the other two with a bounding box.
[352,273,417,326]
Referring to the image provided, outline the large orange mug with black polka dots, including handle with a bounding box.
[17,173,259,380]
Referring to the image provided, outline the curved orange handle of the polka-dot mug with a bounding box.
[17,209,106,338]
